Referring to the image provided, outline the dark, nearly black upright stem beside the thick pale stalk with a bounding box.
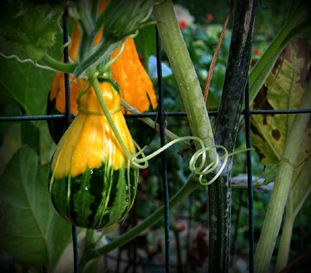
[208,0,257,272]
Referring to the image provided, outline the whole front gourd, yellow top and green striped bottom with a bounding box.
[49,79,138,229]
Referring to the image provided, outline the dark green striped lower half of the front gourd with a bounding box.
[49,162,138,229]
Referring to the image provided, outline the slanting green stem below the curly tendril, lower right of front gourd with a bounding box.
[80,173,200,271]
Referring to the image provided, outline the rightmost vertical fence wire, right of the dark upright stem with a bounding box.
[245,79,254,273]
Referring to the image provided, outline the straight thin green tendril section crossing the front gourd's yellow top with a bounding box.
[90,77,133,160]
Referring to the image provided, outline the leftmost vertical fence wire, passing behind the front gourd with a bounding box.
[63,11,79,273]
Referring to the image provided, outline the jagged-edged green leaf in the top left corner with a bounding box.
[0,0,57,62]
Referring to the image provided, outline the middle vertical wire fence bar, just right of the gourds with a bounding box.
[156,26,170,273]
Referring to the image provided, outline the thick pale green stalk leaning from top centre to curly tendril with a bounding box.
[153,1,214,151]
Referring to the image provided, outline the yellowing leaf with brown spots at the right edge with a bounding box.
[251,37,310,164]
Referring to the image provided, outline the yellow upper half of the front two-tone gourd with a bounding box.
[51,81,135,179]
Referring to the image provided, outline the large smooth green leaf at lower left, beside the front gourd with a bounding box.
[0,146,71,272]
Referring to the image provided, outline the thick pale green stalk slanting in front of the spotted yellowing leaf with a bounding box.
[255,76,311,273]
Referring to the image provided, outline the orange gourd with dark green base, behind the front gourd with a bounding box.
[47,6,157,144]
